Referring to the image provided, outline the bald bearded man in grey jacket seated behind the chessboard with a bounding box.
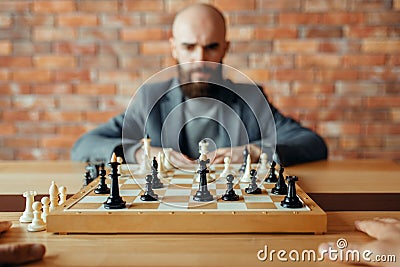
[71,4,327,166]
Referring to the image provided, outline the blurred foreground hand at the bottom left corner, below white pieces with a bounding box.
[0,221,46,265]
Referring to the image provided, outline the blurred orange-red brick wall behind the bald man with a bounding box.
[0,0,400,160]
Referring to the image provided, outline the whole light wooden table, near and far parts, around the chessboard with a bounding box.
[0,160,400,266]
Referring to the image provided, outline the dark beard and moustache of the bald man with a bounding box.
[178,62,222,98]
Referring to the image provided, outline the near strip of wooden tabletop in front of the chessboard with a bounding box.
[0,212,400,267]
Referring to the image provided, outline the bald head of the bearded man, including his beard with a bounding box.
[170,4,229,97]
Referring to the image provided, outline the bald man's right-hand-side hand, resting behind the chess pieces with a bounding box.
[208,144,261,164]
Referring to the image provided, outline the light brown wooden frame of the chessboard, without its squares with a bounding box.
[47,164,327,234]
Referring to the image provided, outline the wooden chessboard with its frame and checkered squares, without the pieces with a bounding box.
[47,165,327,234]
